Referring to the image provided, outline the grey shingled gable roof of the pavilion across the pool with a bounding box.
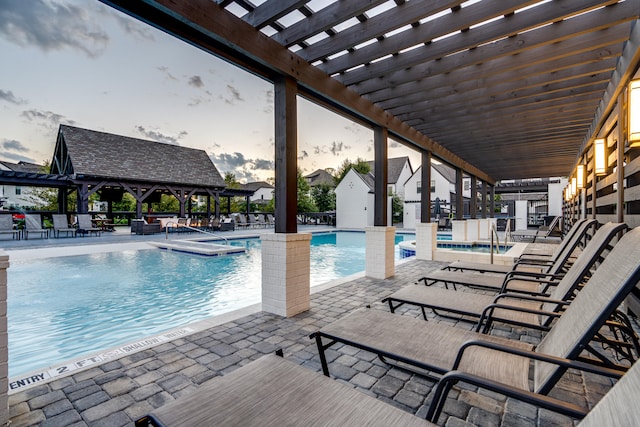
[51,125,226,188]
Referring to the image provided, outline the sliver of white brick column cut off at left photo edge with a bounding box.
[0,252,9,426]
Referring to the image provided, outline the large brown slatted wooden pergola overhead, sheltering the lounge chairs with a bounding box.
[96,0,640,232]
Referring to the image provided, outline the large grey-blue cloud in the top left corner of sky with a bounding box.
[0,0,109,58]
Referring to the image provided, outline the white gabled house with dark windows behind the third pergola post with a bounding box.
[403,164,471,228]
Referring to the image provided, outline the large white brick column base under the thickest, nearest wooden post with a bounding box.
[261,233,311,317]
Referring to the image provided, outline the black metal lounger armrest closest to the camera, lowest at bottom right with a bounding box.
[426,371,588,422]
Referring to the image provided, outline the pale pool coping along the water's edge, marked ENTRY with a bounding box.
[5,239,415,395]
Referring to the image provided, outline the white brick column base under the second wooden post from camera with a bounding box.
[365,226,396,279]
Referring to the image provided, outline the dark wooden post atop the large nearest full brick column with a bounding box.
[275,77,298,233]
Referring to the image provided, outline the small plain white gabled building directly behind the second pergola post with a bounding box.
[335,169,392,229]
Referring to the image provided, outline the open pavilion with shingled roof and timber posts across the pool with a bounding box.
[51,125,226,218]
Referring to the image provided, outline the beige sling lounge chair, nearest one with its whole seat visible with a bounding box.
[311,228,640,394]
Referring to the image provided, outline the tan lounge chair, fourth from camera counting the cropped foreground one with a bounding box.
[418,220,595,295]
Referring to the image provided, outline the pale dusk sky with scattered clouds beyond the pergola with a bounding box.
[0,0,420,182]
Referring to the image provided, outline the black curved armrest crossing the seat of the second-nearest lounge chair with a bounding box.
[451,339,626,379]
